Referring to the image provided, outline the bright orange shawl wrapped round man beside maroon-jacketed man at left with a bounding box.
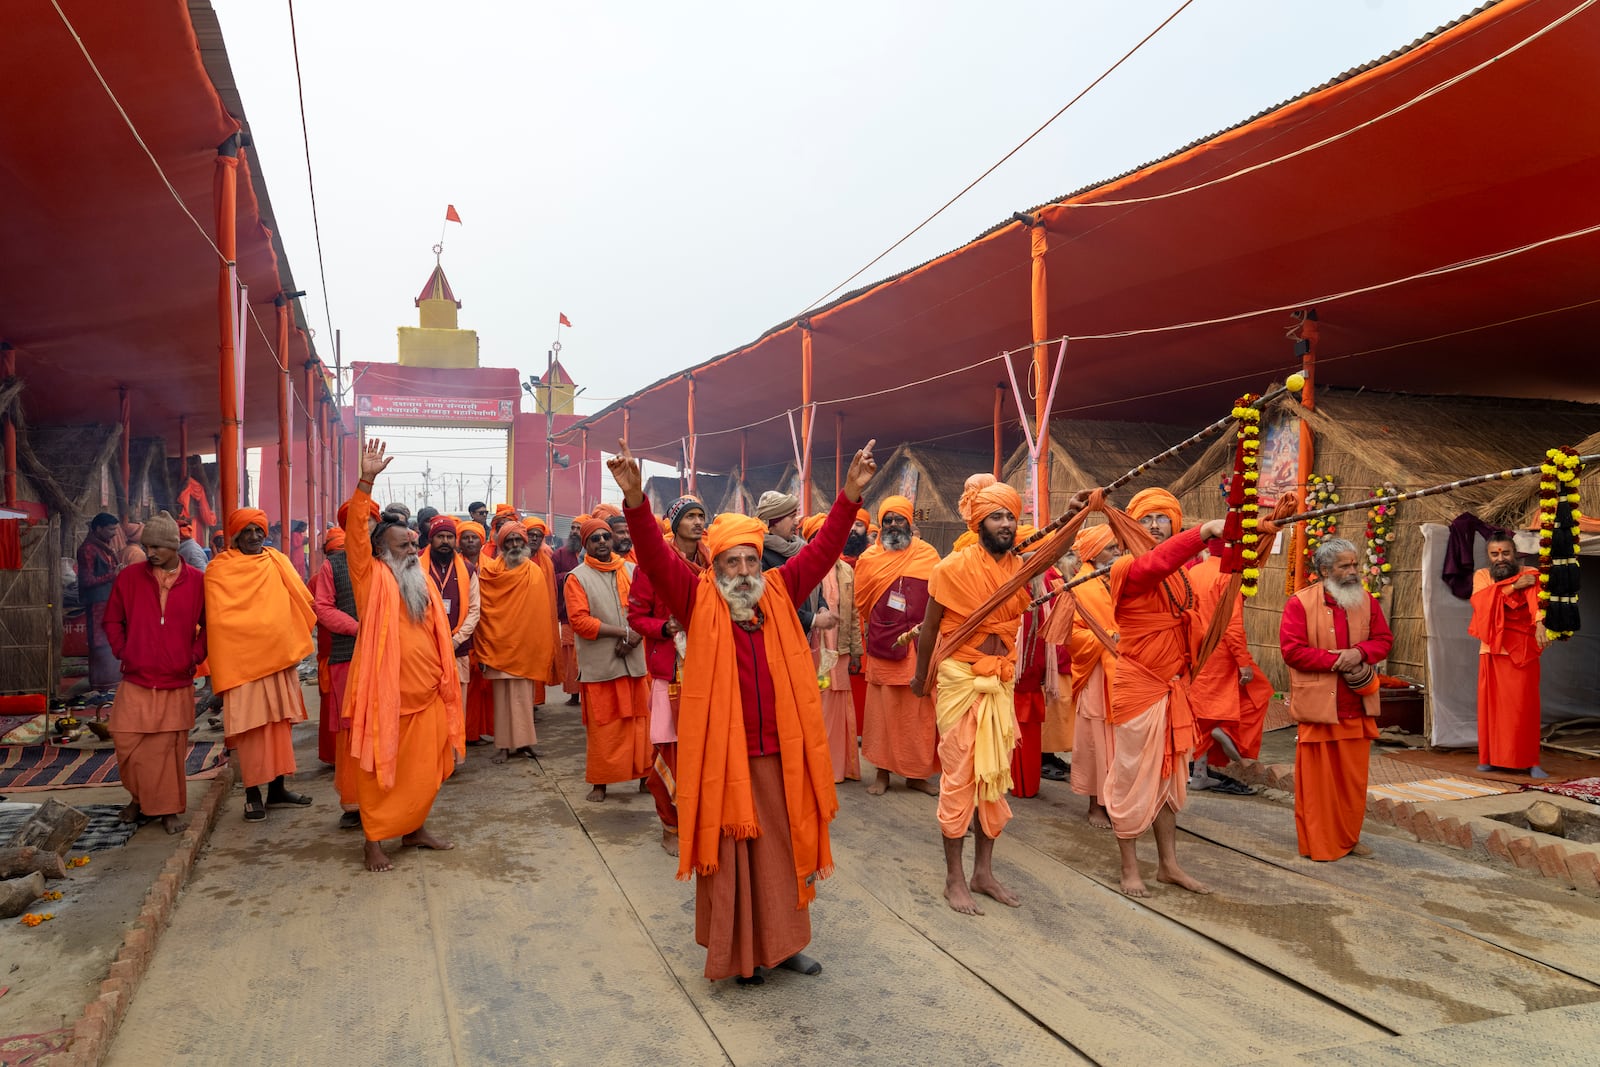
[205,549,317,693]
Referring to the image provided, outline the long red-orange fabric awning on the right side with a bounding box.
[573,0,1600,470]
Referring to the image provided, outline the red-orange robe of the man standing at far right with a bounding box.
[1467,566,1542,771]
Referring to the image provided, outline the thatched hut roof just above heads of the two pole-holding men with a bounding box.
[1003,419,1198,518]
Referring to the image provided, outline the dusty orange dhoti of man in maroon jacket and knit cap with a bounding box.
[110,680,195,816]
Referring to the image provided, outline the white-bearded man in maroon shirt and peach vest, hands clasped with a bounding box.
[1278,537,1394,861]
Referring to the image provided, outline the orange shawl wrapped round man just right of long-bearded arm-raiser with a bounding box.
[472,555,560,683]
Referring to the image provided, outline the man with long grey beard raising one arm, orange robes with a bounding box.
[344,440,467,872]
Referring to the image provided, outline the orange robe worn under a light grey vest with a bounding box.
[566,557,654,785]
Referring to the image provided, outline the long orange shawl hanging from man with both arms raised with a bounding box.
[677,568,838,907]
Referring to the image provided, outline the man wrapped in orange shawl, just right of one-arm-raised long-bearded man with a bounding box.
[472,511,560,763]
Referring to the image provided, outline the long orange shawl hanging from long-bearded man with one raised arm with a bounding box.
[342,560,467,789]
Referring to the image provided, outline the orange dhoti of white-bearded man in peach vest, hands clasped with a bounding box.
[1294,715,1378,859]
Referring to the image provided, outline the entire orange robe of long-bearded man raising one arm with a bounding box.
[346,490,466,841]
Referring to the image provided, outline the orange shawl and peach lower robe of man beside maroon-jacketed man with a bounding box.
[205,543,313,787]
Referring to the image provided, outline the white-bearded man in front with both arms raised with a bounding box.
[606,442,877,984]
